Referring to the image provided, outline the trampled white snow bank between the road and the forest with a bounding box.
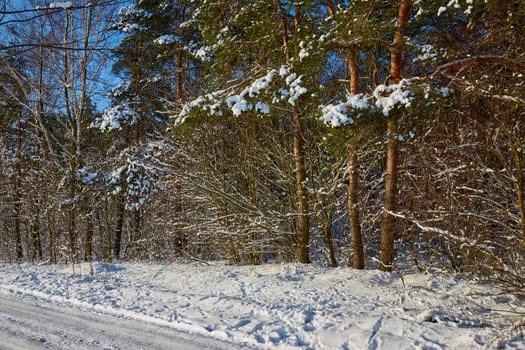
[0,263,525,350]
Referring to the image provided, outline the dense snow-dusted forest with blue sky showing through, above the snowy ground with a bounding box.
[0,0,525,287]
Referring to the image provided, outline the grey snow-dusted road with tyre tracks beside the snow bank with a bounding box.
[0,295,235,350]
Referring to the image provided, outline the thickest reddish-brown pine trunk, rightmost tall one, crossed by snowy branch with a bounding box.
[378,0,412,271]
